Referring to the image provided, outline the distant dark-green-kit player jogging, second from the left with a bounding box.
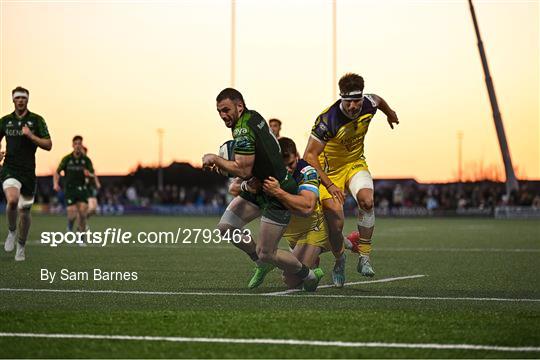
[53,135,94,246]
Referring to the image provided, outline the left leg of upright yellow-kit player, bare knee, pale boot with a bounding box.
[322,199,346,287]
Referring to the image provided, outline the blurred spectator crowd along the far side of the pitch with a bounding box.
[27,179,540,212]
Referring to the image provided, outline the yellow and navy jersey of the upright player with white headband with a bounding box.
[311,94,377,174]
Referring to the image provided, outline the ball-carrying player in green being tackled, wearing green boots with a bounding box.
[202,88,319,291]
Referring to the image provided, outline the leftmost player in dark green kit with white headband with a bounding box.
[0,86,52,261]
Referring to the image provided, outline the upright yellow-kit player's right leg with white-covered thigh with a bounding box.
[349,170,375,277]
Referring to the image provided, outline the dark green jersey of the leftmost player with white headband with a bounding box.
[0,111,50,173]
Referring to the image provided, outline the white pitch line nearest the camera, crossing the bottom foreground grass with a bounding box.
[0,332,540,352]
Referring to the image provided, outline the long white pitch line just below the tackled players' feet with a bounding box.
[0,288,540,302]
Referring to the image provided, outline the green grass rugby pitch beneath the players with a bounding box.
[0,216,540,358]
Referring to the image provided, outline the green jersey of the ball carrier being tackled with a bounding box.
[232,109,287,182]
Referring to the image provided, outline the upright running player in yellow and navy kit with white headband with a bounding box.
[304,73,399,286]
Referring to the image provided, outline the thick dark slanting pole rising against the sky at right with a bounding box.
[469,0,519,194]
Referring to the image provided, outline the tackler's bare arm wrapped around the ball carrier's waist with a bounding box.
[263,177,319,216]
